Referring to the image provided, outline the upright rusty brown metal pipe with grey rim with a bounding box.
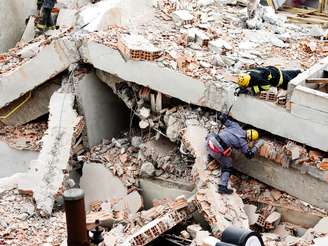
[64,189,90,246]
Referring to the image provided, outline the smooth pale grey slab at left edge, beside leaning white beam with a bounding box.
[0,141,39,178]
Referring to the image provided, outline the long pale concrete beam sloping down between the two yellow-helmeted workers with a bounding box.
[80,40,328,151]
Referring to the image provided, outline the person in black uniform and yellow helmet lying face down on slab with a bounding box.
[237,66,301,94]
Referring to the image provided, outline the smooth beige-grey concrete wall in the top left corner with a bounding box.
[0,0,36,53]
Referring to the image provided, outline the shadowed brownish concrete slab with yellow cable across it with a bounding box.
[0,81,60,125]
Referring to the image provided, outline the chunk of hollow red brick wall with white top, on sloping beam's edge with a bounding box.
[117,35,162,61]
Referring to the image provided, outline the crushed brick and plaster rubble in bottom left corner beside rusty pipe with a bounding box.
[0,189,66,246]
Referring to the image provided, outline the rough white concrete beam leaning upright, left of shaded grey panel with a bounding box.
[18,91,77,215]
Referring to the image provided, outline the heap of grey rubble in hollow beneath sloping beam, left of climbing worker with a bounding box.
[82,133,193,188]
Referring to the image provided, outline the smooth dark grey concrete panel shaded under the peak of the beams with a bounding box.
[78,72,130,147]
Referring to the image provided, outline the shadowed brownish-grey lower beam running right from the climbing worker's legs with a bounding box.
[234,153,328,209]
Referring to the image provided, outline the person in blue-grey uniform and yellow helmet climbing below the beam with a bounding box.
[206,114,264,194]
